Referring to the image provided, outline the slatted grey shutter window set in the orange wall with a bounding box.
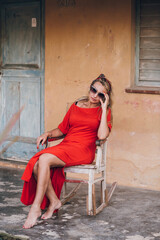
[135,0,160,87]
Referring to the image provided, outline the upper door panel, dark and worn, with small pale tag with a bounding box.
[2,3,41,69]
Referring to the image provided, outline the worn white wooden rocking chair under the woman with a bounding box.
[45,136,117,215]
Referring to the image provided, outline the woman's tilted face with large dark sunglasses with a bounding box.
[89,82,106,104]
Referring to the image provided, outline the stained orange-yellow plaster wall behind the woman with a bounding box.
[45,0,160,190]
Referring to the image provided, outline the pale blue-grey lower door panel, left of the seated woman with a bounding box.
[3,77,40,138]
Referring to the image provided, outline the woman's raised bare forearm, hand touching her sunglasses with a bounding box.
[97,94,110,139]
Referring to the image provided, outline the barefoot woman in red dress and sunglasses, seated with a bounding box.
[21,74,112,228]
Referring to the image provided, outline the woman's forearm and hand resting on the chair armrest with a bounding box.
[37,128,63,149]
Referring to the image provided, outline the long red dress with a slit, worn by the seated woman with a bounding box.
[21,103,112,209]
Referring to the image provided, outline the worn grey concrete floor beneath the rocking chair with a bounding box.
[0,167,160,240]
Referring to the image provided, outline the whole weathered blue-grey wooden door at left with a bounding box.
[0,0,44,160]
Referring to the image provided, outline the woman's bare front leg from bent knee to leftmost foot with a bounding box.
[23,153,65,228]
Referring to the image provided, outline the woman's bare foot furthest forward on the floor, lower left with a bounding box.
[23,205,41,229]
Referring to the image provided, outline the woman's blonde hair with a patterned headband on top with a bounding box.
[90,74,112,107]
